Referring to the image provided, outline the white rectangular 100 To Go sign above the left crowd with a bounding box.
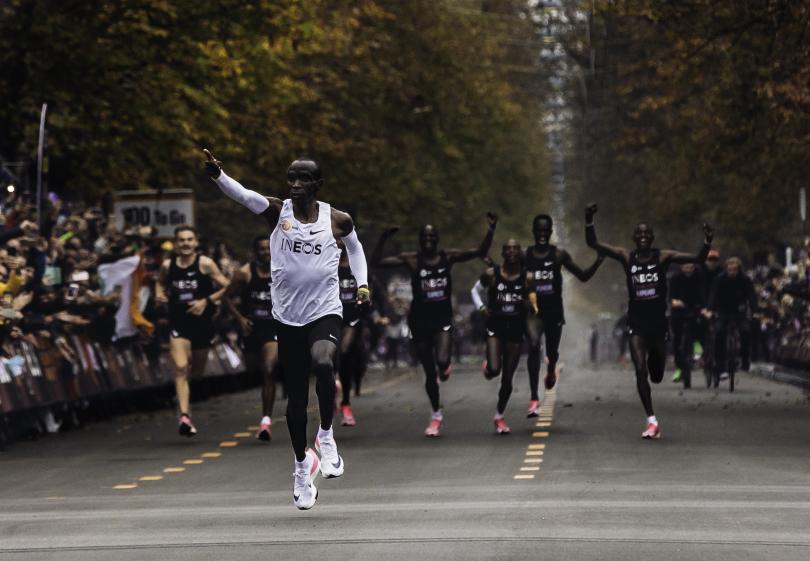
[113,189,195,238]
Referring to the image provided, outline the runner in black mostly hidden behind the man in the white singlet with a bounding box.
[338,242,366,427]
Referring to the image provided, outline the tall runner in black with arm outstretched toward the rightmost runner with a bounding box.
[524,214,605,418]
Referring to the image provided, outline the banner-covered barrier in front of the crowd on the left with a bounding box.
[0,335,245,414]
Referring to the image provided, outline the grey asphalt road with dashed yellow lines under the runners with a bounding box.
[0,352,810,561]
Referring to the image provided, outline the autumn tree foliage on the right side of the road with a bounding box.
[556,0,810,253]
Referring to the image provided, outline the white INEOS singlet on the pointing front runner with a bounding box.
[270,199,343,326]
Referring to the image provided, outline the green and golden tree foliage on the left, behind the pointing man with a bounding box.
[0,0,547,258]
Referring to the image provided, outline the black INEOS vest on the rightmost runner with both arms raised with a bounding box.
[627,249,667,320]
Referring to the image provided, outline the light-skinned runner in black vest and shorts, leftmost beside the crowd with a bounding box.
[155,226,228,437]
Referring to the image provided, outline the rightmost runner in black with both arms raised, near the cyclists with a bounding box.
[585,204,714,438]
